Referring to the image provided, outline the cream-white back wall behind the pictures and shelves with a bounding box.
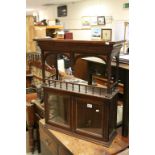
[36,0,129,39]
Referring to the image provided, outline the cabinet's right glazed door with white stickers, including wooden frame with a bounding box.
[74,98,103,139]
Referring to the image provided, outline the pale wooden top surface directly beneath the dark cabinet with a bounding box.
[39,120,128,155]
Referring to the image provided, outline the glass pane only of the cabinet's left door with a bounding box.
[48,94,70,125]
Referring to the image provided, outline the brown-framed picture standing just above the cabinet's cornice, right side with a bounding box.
[101,29,112,41]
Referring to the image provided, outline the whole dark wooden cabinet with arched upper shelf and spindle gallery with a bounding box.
[35,38,123,146]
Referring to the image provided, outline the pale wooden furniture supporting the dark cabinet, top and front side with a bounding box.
[39,119,129,155]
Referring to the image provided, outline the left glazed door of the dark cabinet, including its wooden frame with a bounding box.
[46,93,71,130]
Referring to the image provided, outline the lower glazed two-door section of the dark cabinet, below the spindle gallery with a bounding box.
[44,86,117,146]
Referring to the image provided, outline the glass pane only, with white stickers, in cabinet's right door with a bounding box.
[77,100,102,135]
